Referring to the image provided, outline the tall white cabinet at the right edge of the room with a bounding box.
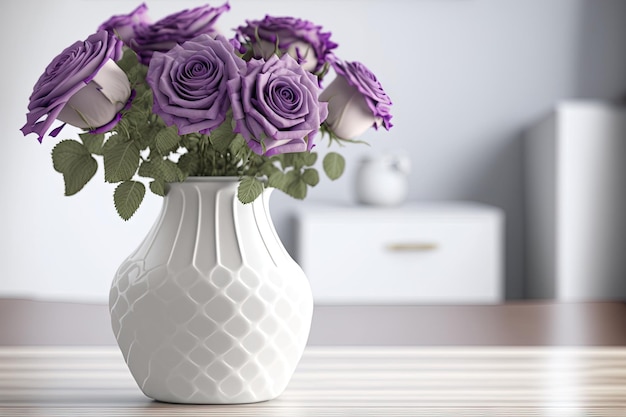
[525,102,626,301]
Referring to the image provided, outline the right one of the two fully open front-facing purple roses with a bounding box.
[228,55,328,156]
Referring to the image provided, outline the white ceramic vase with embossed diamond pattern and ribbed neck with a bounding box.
[110,177,313,404]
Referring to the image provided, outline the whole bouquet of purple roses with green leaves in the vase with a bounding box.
[22,4,391,220]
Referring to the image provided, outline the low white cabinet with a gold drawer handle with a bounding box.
[296,203,503,304]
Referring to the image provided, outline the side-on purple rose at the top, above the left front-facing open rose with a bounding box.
[130,3,230,65]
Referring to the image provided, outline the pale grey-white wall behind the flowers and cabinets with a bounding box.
[0,0,626,301]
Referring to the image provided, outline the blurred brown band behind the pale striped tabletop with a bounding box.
[0,298,626,346]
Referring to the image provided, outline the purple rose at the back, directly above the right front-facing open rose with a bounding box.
[237,16,337,73]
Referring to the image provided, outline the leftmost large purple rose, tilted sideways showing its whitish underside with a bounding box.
[21,31,131,142]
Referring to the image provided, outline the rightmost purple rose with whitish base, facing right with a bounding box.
[320,60,392,139]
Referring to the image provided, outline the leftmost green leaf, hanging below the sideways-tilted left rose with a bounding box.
[52,140,98,195]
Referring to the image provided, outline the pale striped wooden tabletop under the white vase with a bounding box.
[0,346,626,417]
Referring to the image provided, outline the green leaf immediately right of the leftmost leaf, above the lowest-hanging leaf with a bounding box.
[102,135,139,182]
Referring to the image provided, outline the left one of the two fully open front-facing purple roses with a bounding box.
[146,34,246,135]
